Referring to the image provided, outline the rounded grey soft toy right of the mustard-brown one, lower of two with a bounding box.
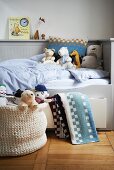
[81,54,99,69]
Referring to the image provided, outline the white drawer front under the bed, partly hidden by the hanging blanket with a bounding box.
[43,98,107,129]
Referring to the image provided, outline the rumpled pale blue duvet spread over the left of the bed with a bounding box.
[0,59,70,94]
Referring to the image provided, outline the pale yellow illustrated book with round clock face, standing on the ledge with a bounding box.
[9,17,30,40]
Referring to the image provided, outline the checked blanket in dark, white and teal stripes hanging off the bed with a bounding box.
[50,92,99,144]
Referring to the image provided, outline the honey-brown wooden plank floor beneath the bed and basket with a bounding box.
[0,131,114,170]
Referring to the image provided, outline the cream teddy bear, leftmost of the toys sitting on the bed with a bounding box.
[42,48,55,63]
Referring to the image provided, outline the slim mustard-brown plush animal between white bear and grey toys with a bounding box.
[70,50,81,68]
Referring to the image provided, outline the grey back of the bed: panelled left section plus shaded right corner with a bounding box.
[0,40,111,72]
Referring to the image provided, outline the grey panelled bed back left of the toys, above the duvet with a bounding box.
[0,40,48,61]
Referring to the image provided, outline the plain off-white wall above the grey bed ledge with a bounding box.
[0,0,114,39]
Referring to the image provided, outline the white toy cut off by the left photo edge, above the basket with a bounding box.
[0,84,7,106]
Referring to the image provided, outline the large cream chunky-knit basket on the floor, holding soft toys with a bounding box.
[0,106,47,156]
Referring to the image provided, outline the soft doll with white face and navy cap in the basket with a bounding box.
[35,84,51,103]
